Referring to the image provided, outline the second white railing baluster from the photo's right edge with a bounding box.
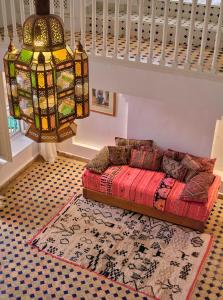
[198,0,212,71]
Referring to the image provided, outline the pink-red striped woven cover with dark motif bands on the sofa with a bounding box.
[83,165,221,221]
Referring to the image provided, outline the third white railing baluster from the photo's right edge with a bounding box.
[184,0,197,69]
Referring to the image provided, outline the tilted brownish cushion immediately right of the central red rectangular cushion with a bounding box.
[162,155,187,181]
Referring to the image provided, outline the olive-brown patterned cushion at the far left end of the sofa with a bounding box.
[86,147,110,174]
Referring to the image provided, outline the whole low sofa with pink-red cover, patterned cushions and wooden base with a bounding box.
[82,138,221,232]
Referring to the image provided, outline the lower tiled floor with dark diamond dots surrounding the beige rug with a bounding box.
[0,157,223,300]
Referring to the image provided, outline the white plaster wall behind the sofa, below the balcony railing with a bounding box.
[60,58,223,169]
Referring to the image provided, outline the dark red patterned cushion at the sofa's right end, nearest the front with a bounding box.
[181,172,215,203]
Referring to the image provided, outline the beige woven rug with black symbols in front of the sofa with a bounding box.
[29,196,212,300]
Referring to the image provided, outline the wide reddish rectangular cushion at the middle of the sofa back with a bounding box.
[129,148,163,171]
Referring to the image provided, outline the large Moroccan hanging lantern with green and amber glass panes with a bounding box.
[4,0,89,143]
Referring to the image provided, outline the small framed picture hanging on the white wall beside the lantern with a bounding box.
[91,89,116,117]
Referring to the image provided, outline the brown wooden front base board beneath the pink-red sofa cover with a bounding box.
[83,188,205,232]
